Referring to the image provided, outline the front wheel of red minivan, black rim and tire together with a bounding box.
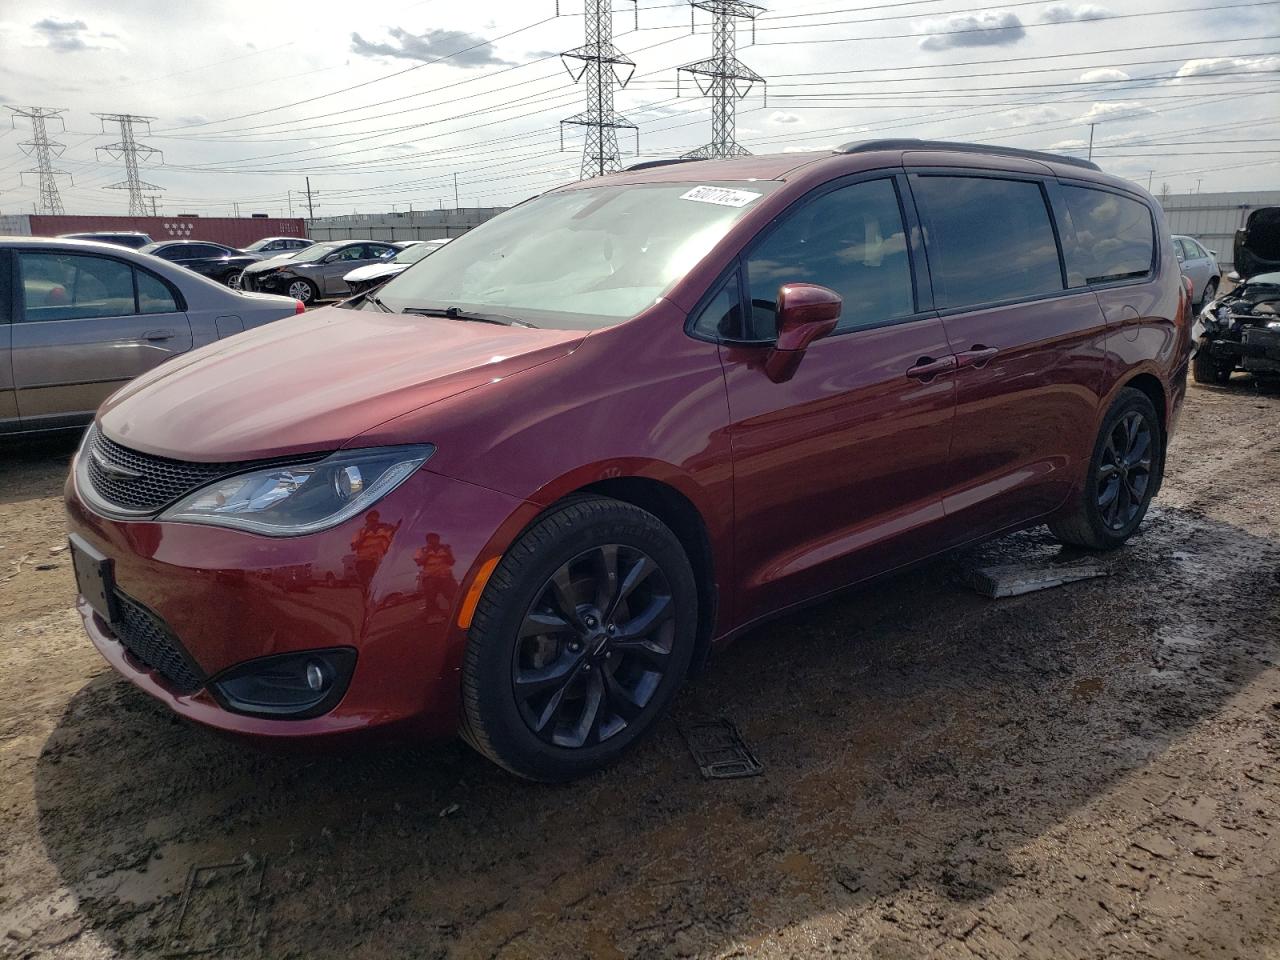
[460,497,698,782]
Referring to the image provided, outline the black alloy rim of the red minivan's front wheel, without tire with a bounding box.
[511,543,676,749]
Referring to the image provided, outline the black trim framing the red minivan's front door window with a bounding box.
[685,166,937,347]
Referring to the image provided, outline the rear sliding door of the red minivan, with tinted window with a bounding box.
[910,173,1107,541]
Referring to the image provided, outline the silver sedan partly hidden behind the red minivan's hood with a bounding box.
[0,237,302,434]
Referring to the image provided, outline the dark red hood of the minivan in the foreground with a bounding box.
[97,307,586,462]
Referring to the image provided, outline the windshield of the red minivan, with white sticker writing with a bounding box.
[379,180,782,329]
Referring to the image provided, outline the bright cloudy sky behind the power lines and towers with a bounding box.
[0,0,1280,215]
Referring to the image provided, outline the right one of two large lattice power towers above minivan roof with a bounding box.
[676,0,765,159]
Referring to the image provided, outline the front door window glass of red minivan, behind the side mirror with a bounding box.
[746,179,915,339]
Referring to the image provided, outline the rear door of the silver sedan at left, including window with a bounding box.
[10,251,191,430]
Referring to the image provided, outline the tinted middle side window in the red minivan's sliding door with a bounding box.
[911,177,1062,310]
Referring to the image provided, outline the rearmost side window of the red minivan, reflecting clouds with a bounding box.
[1062,187,1156,287]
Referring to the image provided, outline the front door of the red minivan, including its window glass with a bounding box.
[712,177,955,623]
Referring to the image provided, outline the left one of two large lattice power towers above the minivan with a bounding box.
[561,0,640,180]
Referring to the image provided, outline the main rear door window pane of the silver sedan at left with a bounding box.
[18,253,136,321]
